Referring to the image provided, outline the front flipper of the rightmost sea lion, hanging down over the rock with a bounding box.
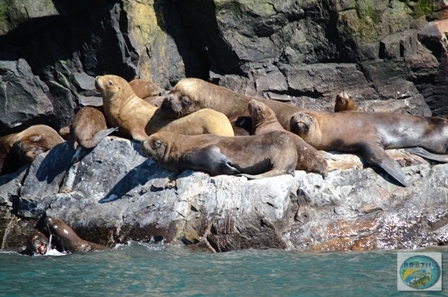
[363,144,407,187]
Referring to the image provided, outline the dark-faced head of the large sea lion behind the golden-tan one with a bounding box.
[160,90,198,118]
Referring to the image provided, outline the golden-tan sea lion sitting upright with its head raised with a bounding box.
[95,75,234,141]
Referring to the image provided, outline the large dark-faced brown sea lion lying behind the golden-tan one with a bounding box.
[161,78,302,130]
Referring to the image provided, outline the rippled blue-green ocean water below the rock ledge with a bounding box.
[0,242,448,297]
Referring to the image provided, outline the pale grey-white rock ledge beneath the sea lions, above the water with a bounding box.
[0,137,448,251]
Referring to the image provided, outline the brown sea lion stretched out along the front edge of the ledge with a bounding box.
[142,131,297,179]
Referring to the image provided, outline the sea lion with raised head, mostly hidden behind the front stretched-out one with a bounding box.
[248,99,328,177]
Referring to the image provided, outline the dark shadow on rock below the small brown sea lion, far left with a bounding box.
[36,142,75,183]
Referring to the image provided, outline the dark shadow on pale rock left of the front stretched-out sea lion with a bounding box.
[98,160,169,203]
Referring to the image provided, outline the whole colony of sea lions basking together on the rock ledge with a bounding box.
[7,75,448,254]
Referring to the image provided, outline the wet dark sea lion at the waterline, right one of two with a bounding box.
[45,217,110,253]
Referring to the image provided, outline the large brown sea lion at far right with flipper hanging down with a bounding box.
[291,111,448,186]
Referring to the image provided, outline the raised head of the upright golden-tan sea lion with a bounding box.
[95,74,131,105]
